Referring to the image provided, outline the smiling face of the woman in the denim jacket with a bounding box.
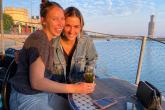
[64,16,81,41]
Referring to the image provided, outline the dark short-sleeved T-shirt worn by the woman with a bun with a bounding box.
[11,31,54,94]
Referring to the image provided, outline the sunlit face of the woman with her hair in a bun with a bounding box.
[42,6,65,37]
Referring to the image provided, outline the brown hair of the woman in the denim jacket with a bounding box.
[65,7,84,32]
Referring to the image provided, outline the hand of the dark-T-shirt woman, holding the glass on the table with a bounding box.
[68,82,96,94]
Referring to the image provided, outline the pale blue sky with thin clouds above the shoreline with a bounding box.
[3,0,165,37]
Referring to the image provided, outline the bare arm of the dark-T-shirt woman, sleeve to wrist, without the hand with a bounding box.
[29,57,70,93]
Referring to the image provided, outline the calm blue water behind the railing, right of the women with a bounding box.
[94,40,165,94]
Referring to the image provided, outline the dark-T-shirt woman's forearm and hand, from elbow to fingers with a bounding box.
[32,78,96,93]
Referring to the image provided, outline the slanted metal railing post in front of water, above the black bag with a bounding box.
[135,36,147,85]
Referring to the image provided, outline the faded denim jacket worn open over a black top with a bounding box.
[53,37,98,83]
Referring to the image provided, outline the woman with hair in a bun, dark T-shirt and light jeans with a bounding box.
[10,1,95,110]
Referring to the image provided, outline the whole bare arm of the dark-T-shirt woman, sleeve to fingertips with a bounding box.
[30,57,95,93]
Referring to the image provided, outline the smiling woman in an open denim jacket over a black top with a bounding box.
[53,7,97,87]
